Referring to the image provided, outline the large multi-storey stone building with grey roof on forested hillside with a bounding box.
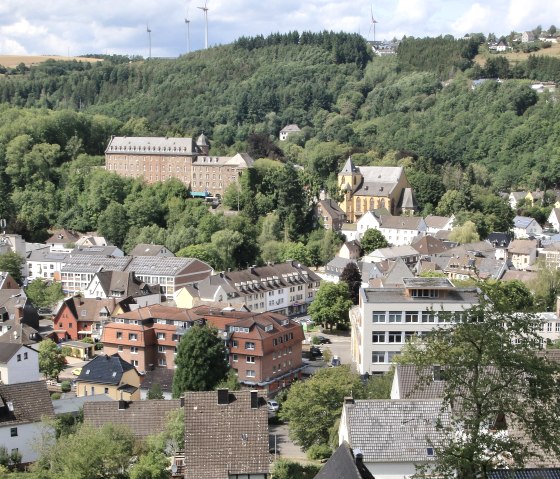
[105,135,253,196]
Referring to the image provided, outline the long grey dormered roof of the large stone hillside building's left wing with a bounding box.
[105,136,198,156]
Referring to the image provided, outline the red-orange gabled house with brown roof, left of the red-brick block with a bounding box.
[53,296,117,341]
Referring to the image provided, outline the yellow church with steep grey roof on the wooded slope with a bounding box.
[338,158,417,223]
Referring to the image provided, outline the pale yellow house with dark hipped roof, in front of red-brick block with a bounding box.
[76,354,140,401]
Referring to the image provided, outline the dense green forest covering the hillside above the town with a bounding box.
[0,32,560,267]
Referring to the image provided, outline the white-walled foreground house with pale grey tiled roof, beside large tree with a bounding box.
[338,398,451,479]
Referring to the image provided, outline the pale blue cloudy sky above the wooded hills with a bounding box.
[0,0,560,57]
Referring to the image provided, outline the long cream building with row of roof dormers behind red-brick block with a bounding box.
[197,261,321,316]
